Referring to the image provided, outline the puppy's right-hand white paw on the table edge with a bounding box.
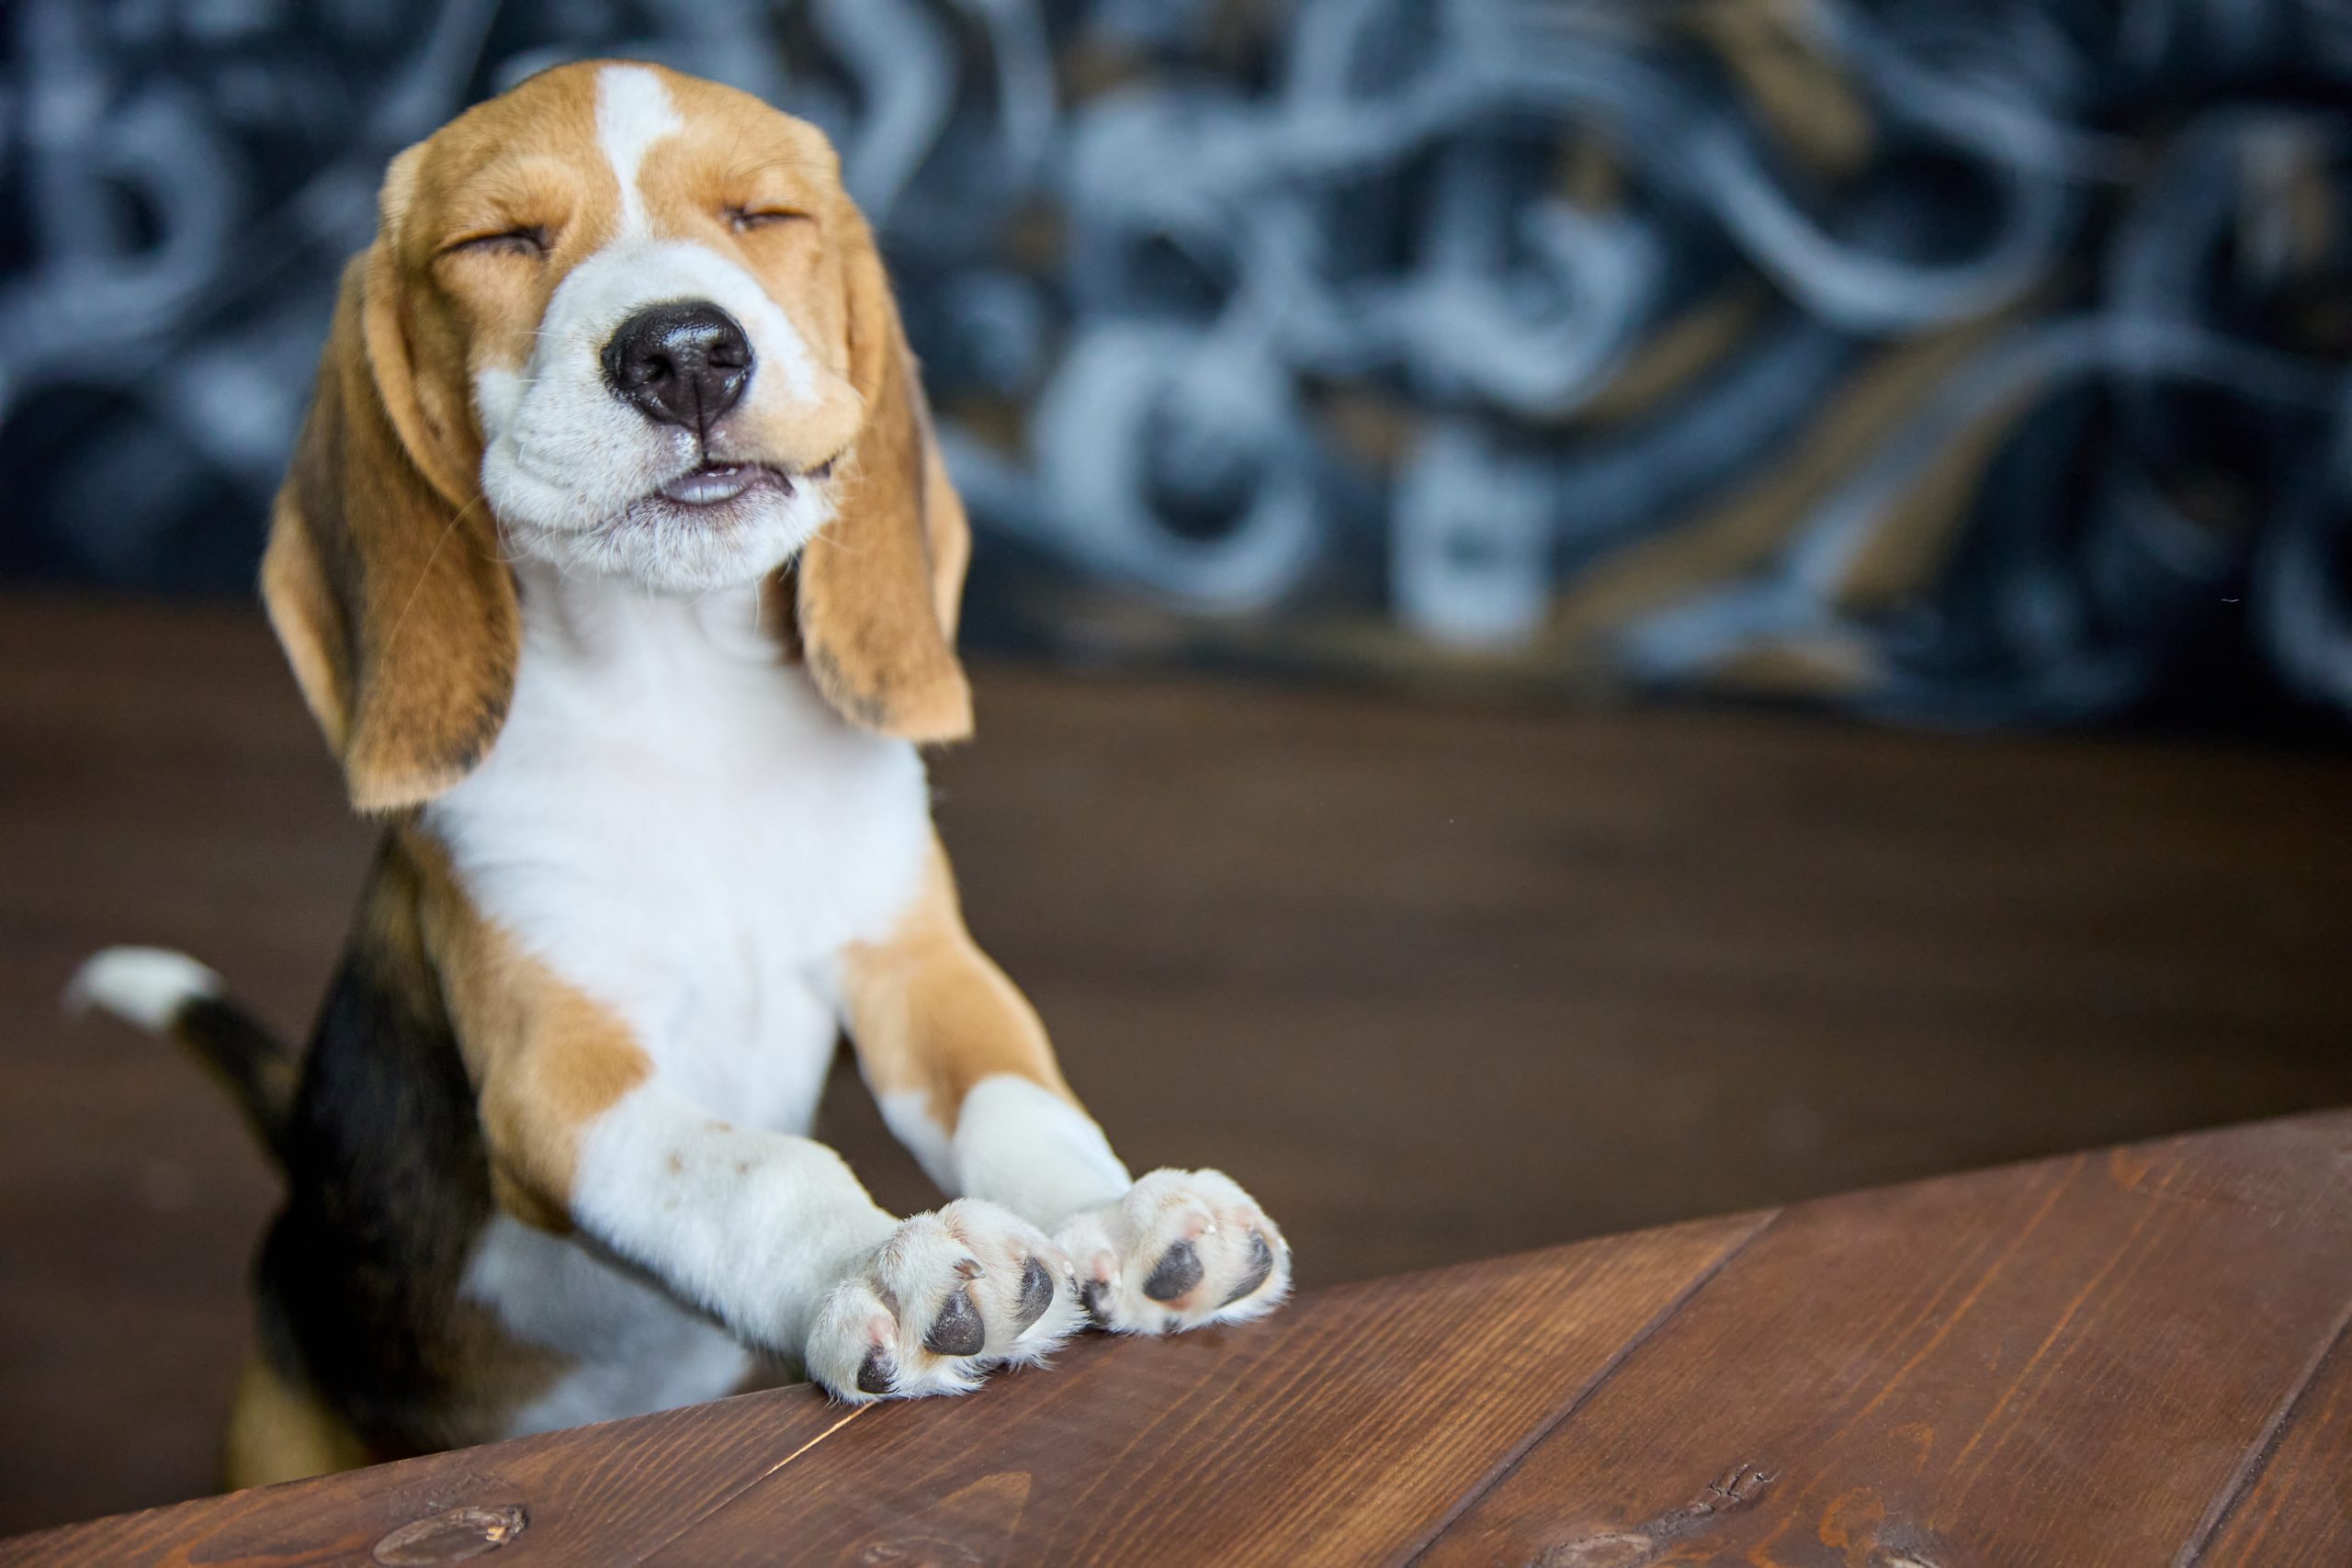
[1054,1170,1291,1333]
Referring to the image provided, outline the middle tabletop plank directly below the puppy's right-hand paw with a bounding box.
[625,1218,1761,1565]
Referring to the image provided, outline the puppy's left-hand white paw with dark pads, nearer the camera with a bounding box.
[805,1199,1084,1404]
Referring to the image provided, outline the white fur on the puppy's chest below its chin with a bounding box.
[425,567,929,1134]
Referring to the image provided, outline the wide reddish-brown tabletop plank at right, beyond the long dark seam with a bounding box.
[1423,1114,2352,1568]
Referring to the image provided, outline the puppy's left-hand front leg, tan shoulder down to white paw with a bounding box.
[437,869,1084,1401]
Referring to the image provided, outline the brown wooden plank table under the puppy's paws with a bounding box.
[0,1112,2352,1568]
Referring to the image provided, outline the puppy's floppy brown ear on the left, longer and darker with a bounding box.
[261,152,520,811]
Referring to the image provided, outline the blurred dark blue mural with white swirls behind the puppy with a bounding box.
[0,0,2352,724]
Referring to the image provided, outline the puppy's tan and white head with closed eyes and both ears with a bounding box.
[261,63,971,811]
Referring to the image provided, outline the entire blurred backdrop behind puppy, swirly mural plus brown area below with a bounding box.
[0,0,2352,1530]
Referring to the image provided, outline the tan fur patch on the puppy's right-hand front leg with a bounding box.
[842,841,1077,1134]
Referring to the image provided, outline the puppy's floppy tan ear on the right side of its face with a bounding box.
[797,197,971,740]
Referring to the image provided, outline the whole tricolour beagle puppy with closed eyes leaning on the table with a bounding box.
[77,63,1291,1485]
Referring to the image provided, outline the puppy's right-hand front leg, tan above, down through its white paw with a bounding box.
[842,849,1291,1333]
